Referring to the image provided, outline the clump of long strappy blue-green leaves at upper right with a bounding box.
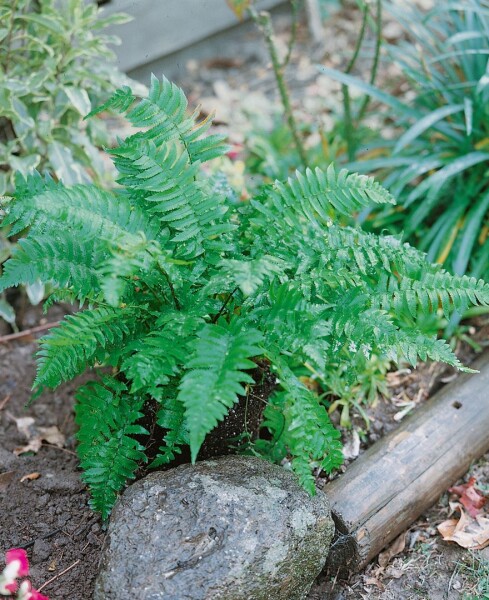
[321,0,489,277]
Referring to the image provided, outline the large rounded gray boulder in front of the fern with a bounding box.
[94,456,334,600]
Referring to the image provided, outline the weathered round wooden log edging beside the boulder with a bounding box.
[324,353,489,574]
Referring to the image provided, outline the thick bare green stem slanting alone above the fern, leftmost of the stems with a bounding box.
[249,7,307,167]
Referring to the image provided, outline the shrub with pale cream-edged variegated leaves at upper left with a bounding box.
[0,0,143,327]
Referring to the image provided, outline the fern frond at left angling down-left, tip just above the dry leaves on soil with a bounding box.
[34,307,141,388]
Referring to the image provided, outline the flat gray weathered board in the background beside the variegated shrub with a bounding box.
[103,0,284,72]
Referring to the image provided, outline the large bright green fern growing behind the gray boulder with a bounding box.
[0,78,489,518]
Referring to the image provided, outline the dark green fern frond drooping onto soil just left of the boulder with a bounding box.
[75,378,148,520]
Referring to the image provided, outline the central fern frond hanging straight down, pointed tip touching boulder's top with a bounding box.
[178,321,263,461]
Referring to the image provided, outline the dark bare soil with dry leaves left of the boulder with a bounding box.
[0,307,104,600]
